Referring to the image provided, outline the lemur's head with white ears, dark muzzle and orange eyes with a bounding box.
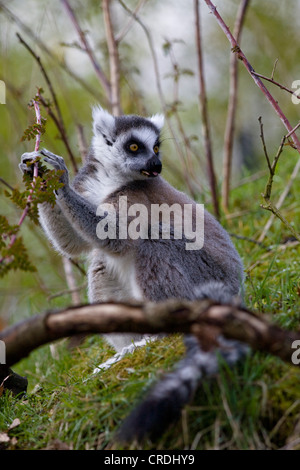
[93,108,163,180]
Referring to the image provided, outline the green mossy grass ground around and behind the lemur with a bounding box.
[0,155,300,449]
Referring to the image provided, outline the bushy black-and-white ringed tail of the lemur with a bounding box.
[117,282,248,443]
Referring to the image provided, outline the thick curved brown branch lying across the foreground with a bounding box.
[0,300,300,368]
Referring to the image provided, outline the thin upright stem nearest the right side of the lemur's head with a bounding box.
[194,0,220,218]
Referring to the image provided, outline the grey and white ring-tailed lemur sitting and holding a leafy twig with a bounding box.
[20,107,245,441]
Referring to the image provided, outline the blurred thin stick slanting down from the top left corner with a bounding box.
[0,2,99,99]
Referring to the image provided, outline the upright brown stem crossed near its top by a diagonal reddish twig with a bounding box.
[222,0,249,212]
